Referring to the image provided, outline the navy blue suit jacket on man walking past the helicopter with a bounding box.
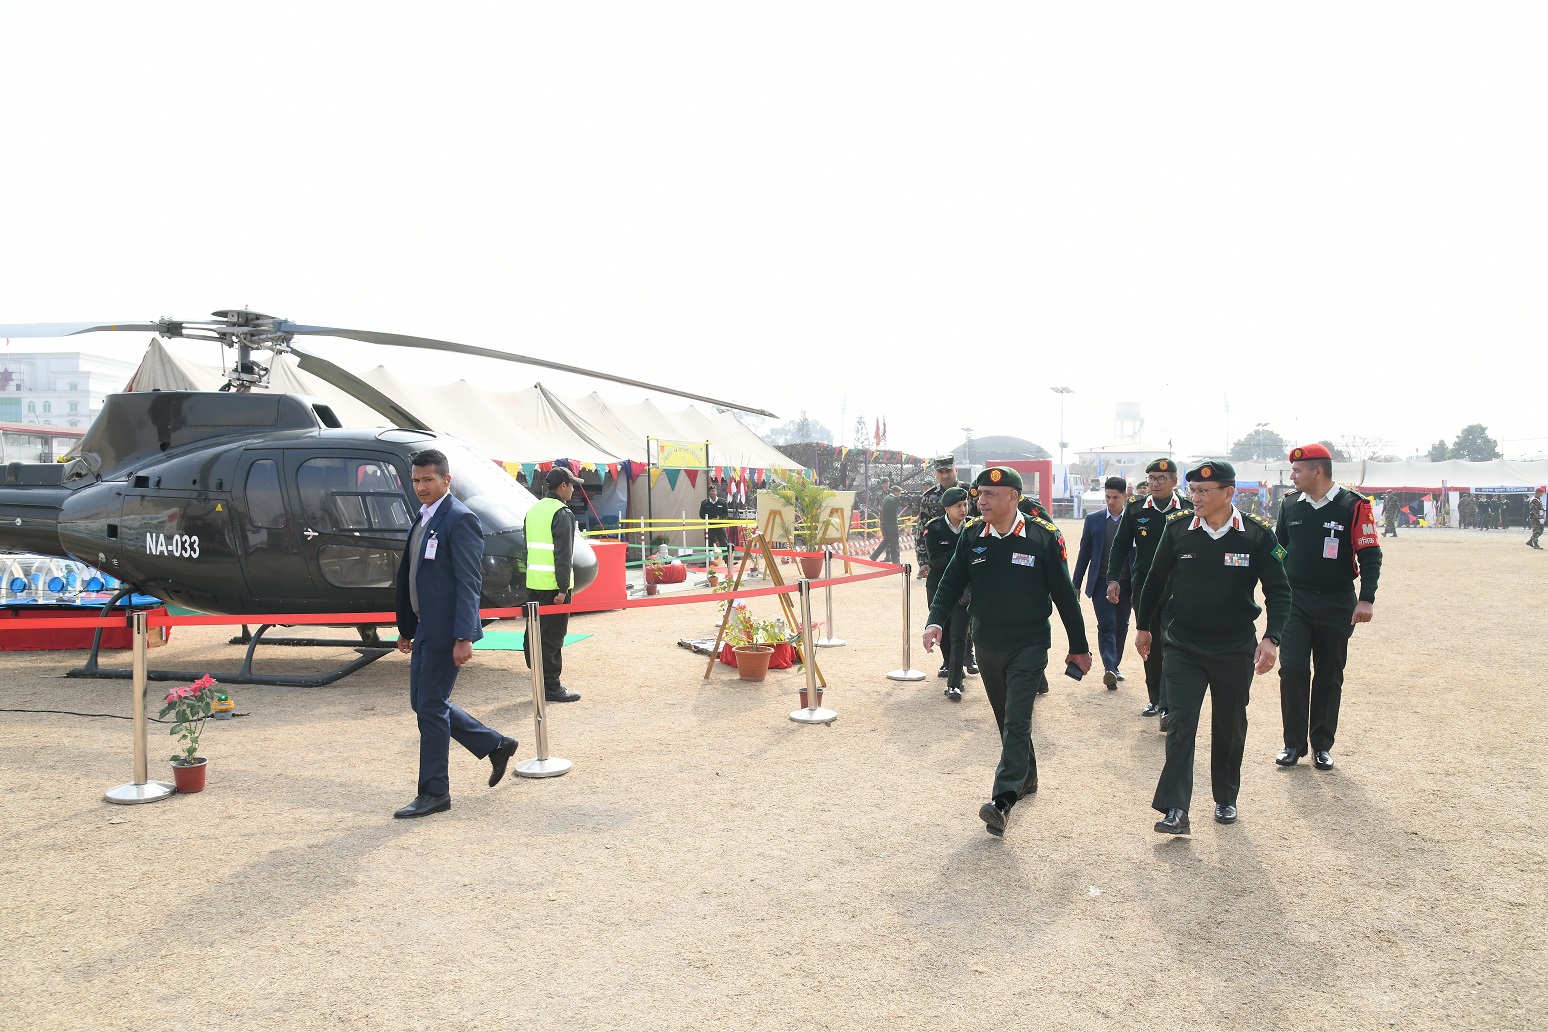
[398,495,483,650]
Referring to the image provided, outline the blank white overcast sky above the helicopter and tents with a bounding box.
[0,0,1548,458]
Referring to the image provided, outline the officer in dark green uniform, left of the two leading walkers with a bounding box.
[924,466,1091,836]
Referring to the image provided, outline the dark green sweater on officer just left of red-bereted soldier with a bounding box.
[1135,511,1289,650]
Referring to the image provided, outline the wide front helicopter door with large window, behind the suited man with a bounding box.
[288,452,413,610]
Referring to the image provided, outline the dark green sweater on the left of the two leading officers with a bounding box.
[929,517,1091,654]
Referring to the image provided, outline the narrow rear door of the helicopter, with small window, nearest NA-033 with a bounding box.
[237,452,316,613]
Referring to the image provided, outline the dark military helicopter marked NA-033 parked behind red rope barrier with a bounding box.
[0,309,772,684]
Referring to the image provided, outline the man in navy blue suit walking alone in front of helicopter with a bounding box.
[393,449,515,817]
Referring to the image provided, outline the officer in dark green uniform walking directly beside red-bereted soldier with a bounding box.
[1135,460,1289,836]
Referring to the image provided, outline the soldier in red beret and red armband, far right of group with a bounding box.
[1274,444,1381,771]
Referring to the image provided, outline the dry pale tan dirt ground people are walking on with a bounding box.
[0,531,1548,1030]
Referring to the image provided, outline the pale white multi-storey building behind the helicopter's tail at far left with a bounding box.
[0,350,138,430]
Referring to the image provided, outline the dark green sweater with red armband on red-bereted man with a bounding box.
[1274,487,1381,602]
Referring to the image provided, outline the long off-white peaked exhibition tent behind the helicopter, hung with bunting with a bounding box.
[127,337,800,543]
